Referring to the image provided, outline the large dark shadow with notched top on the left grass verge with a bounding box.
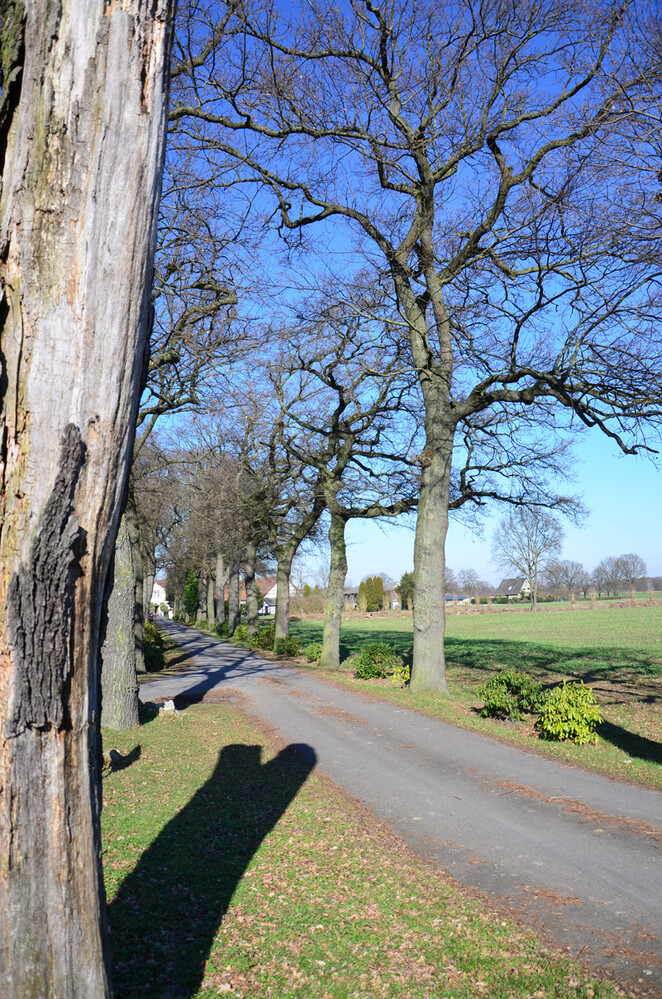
[108,745,316,999]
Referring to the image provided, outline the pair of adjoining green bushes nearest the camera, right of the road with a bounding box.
[478,669,602,745]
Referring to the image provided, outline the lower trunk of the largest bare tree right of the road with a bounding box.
[411,414,454,693]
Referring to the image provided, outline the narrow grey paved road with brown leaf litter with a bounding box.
[140,620,662,996]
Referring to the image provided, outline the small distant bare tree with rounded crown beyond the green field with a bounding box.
[492,508,563,611]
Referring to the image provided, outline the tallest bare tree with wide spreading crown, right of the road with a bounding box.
[171,0,662,690]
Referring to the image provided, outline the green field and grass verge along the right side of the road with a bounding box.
[291,605,662,788]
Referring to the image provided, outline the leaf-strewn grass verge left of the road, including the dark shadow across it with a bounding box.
[103,704,625,999]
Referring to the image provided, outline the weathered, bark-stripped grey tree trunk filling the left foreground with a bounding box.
[0,0,172,999]
